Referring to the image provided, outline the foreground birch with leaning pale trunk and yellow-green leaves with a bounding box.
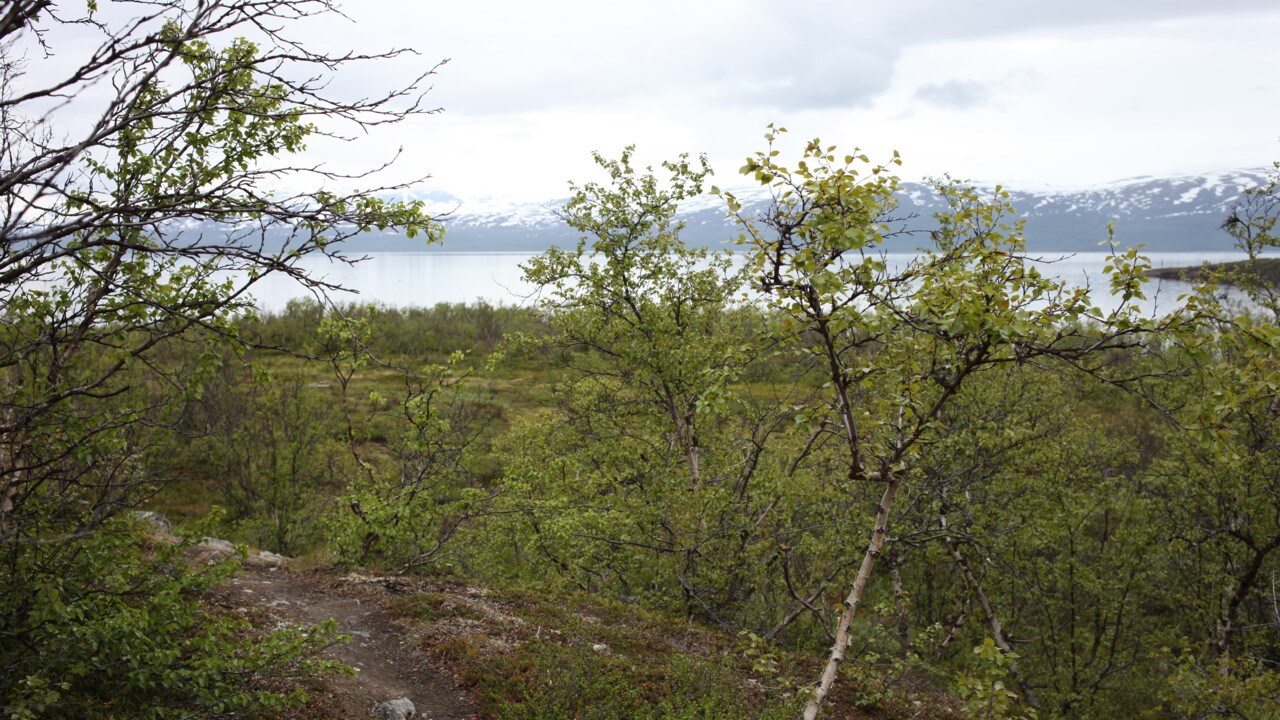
[724,128,1146,720]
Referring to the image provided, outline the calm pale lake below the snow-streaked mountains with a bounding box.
[244,252,1242,313]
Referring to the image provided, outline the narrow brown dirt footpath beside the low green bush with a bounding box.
[227,569,475,720]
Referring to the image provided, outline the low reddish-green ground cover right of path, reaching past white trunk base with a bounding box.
[366,580,960,720]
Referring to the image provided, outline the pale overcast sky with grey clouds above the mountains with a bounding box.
[15,0,1280,201]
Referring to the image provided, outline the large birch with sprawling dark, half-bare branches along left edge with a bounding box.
[0,0,440,717]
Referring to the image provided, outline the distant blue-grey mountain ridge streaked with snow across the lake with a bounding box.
[332,169,1268,252]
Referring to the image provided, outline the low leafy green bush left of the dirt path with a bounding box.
[0,520,338,720]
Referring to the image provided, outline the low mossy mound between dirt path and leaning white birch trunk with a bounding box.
[398,585,800,720]
